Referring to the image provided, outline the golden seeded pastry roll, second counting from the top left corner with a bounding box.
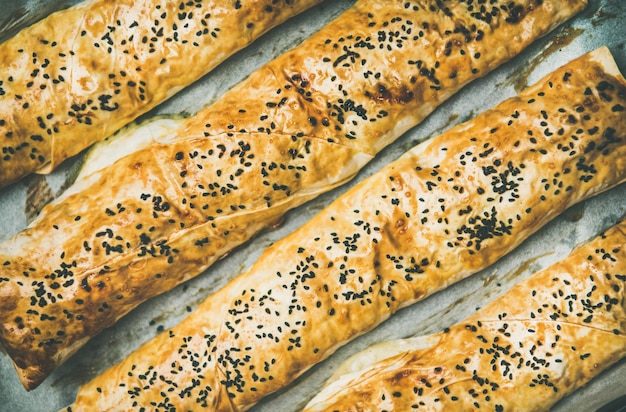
[0,0,585,388]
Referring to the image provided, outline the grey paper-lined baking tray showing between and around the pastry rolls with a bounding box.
[0,0,626,412]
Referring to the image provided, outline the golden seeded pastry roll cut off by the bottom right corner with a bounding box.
[305,221,626,412]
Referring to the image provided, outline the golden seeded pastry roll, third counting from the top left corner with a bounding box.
[68,48,626,411]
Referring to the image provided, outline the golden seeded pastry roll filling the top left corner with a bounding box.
[0,0,321,187]
